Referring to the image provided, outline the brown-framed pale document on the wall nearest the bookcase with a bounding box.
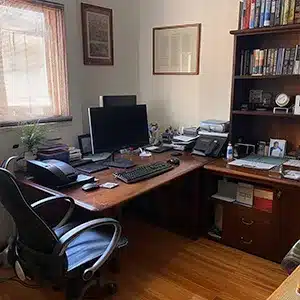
[153,24,201,75]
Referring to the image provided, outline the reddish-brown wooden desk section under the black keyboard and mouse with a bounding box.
[23,152,212,237]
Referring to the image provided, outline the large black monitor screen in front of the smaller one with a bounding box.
[89,105,149,154]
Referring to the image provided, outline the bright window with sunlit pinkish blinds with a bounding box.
[0,0,69,126]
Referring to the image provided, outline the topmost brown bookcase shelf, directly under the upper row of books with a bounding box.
[230,24,300,36]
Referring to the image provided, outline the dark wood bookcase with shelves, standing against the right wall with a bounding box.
[230,24,300,152]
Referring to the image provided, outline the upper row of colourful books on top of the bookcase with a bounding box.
[239,0,300,30]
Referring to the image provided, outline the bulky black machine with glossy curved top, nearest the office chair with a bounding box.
[27,159,78,187]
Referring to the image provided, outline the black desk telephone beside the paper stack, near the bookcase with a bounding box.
[192,135,228,157]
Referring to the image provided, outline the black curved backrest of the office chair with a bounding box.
[0,168,58,254]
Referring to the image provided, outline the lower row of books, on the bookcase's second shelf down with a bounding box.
[240,45,300,76]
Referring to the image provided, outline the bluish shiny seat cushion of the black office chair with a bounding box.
[53,223,128,272]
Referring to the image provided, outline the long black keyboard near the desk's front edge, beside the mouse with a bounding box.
[113,162,174,183]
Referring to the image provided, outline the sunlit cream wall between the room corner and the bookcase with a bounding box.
[139,0,239,126]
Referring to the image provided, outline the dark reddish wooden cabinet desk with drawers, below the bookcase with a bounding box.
[204,159,300,262]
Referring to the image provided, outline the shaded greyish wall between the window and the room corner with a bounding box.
[0,0,139,159]
